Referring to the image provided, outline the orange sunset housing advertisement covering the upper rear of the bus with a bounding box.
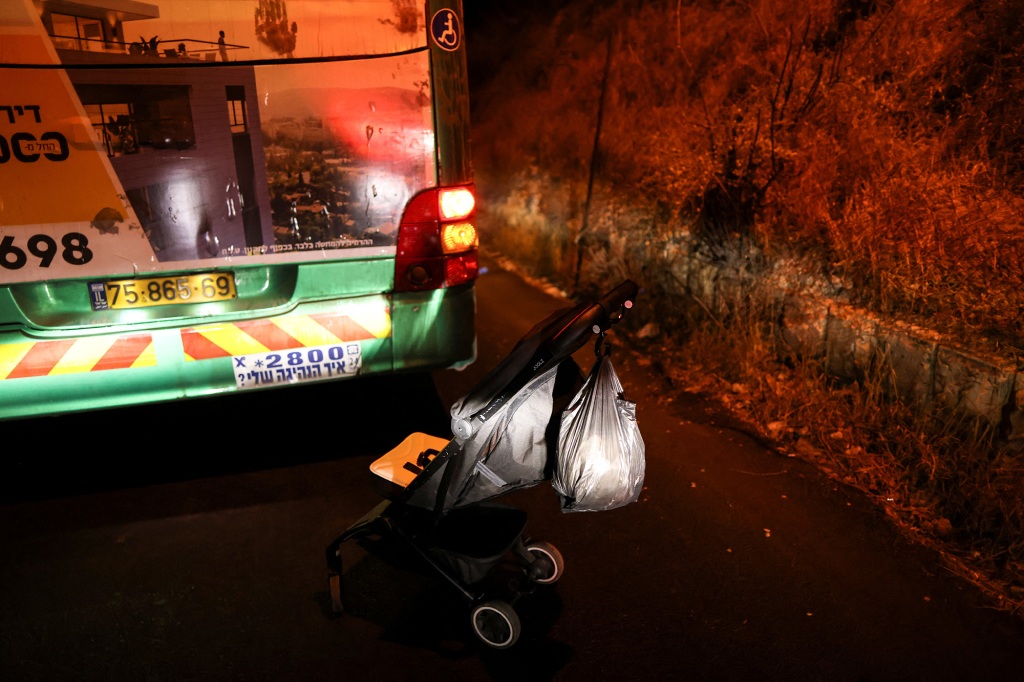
[0,0,436,284]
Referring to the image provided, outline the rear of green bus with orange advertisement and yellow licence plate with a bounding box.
[0,0,478,419]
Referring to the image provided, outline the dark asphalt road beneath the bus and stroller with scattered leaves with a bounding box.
[0,251,1024,682]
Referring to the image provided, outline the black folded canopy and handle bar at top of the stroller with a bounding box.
[452,280,639,442]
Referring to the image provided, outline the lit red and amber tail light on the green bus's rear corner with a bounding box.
[394,186,479,291]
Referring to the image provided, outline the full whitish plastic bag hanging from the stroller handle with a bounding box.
[552,354,646,512]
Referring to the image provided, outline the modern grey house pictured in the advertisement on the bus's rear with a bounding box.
[35,0,274,262]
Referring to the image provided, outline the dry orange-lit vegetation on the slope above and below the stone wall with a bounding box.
[468,0,1024,612]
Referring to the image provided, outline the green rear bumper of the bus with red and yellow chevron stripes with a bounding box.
[0,285,476,420]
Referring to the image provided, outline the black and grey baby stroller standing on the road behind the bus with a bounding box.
[327,280,637,649]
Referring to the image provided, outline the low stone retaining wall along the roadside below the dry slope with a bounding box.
[483,169,1024,446]
